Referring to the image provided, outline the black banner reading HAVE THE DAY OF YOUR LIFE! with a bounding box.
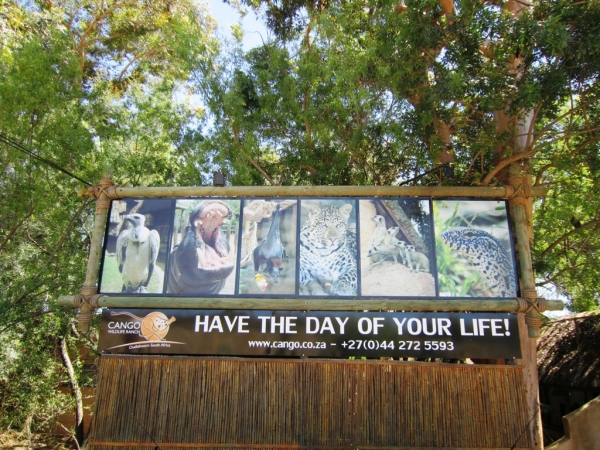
[100,309,521,359]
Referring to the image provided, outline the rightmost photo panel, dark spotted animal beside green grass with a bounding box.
[433,200,517,298]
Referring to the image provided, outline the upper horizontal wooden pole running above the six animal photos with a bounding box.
[79,186,548,199]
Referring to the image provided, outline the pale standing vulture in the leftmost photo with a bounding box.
[117,213,160,294]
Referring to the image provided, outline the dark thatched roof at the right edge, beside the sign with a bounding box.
[537,311,600,389]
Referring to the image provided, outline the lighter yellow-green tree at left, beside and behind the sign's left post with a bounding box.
[0,0,213,441]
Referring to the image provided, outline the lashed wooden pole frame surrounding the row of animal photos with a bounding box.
[59,173,563,449]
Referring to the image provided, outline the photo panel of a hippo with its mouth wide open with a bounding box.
[167,198,240,296]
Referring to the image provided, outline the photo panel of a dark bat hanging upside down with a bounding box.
[238,199,298,296]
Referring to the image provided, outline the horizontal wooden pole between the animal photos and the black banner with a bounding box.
[58,295,564,312]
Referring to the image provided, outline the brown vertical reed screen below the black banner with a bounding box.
[88,356,530,450]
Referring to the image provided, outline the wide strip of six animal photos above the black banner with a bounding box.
[99,197,518,299]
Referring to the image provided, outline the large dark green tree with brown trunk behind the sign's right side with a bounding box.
[203,0,600,310]
